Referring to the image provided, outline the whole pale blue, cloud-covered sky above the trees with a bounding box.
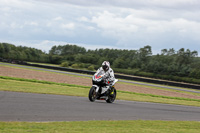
[0,0,200,55]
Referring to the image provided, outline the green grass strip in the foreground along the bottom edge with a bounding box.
[0,120,200,133]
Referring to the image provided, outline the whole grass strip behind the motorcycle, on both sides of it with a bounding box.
[0,76,200,106]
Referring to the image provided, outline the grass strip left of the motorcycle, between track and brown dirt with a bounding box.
[0,77,89,97]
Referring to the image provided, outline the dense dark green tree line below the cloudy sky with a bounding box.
[0,43,200,83]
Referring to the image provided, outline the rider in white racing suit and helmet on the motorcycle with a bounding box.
[96,61,115,95]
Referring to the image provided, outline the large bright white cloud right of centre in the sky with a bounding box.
[91,9,200,38]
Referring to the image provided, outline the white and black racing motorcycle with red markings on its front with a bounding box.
[88,71,118,103]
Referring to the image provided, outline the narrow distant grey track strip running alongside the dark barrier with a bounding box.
[0,62,200,93]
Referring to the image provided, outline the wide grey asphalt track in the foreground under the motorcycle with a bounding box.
[0,91,200,122]
